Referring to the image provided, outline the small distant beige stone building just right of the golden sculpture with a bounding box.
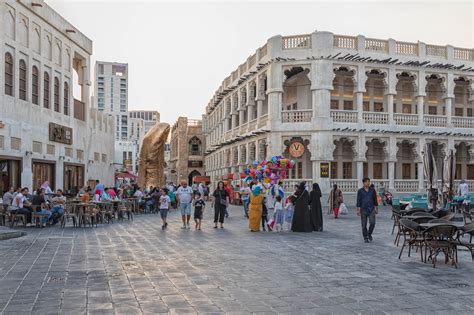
[169,117,204,184]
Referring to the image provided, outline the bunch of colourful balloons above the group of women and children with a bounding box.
[244,155,295,185]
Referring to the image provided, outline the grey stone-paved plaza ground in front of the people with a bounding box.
[0,207,474,314]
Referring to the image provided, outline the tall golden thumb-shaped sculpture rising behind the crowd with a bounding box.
[138,123,170,187]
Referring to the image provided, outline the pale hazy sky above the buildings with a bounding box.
[45,0,474,124]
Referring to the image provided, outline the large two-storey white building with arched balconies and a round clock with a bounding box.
[203,32,474,192]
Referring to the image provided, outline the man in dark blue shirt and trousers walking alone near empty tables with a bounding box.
[357,177,379,243]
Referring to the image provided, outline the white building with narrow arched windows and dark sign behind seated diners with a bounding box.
[0,0,114,193]
